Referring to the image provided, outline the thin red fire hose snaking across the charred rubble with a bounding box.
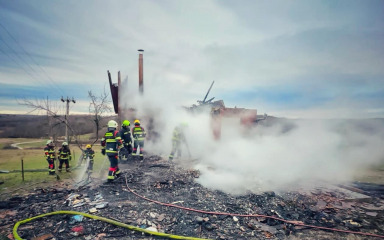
[125,175,384,238]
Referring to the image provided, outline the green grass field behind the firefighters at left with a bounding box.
[0,139,109,197]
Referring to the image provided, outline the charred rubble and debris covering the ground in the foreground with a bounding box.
[0,156,384,240]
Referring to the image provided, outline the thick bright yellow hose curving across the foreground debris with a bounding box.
[13,211,210,240]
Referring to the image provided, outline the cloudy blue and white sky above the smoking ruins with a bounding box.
[0,0,384,118]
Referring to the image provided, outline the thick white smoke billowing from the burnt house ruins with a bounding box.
[118,78,384,194]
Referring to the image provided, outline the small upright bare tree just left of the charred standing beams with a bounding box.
[88,88,112,143]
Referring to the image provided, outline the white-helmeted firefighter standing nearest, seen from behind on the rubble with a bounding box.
[101,120,123,182]
